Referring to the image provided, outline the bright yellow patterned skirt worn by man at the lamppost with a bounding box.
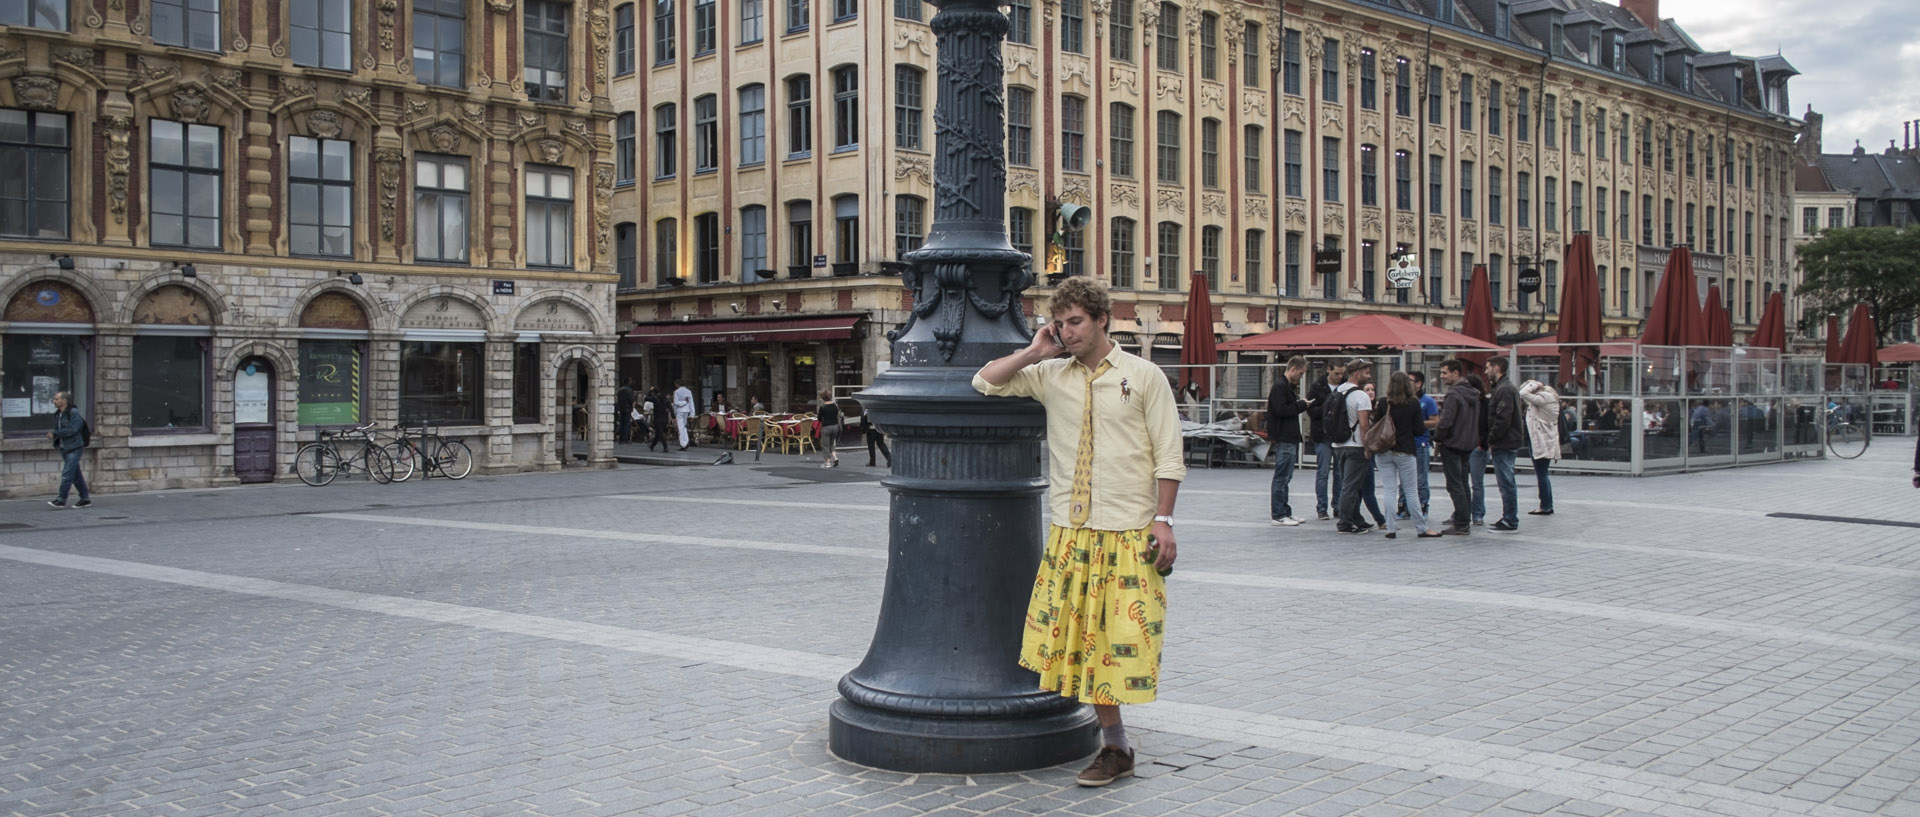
[1020,525,1167,704]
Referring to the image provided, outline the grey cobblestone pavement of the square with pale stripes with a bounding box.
[0,439,1920,817]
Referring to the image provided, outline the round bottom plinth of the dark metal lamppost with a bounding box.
[828,700,1100,775]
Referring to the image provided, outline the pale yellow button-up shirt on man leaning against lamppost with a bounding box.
[973,343,1187,531]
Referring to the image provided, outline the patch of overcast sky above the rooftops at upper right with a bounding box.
[1661,0,1920,153]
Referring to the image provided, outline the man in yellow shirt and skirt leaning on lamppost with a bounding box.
[973,276,1187,786]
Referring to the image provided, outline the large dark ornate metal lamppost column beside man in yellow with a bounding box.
[829,0,1098,773]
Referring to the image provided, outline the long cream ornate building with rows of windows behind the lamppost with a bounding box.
[614,0,1797,406]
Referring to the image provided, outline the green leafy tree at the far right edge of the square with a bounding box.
[1797,226,1920,345]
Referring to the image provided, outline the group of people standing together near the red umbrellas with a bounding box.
[1267,355,1565,539]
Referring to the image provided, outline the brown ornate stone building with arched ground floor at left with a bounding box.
[0,0,616,493]
